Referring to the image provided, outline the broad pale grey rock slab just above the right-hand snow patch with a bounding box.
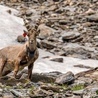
[63,43,96,59]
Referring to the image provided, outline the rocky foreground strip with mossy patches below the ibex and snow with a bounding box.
[0,68,98,98]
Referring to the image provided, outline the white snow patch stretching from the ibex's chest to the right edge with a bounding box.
[33,49,98,74]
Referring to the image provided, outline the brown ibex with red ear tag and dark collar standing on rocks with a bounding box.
[0,18,39,79]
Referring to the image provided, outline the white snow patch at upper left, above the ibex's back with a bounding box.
[0,5,25,48]
